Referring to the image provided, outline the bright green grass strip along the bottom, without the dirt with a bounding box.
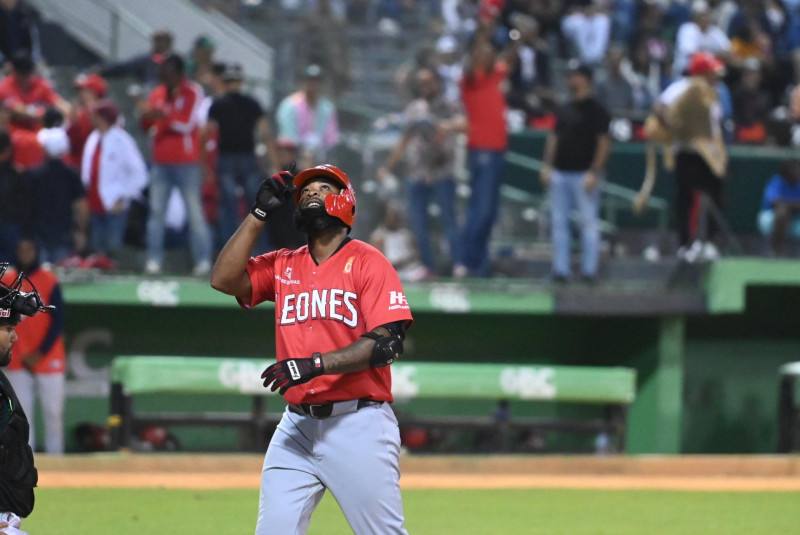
[23,488,800,535]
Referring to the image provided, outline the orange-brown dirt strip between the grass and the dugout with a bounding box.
[36,453,800,491]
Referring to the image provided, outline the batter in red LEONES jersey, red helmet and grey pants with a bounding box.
[211,165,413,535]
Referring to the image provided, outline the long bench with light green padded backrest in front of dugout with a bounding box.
[109,355,636,452]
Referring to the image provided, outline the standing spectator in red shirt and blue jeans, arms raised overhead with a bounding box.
[453,32,509,278]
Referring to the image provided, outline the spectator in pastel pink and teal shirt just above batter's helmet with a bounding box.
[276,65,339,169]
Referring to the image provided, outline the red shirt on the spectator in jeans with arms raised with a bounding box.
[461,61,508,150]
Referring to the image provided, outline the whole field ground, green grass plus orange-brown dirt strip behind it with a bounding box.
[22,453,800,535]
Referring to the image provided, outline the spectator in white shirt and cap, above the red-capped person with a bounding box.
[672,0,731,78]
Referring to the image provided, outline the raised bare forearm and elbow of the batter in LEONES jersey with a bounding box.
[211,214,265,303]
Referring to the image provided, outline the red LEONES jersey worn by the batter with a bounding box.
[239,240,413,404]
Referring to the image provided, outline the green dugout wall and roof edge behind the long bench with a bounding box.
[56,259,800,453]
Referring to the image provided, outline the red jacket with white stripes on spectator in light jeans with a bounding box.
[142,79,203,164]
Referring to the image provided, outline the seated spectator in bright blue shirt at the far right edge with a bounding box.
[758,159,800,256]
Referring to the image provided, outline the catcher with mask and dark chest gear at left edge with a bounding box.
[0,263,54,535]
